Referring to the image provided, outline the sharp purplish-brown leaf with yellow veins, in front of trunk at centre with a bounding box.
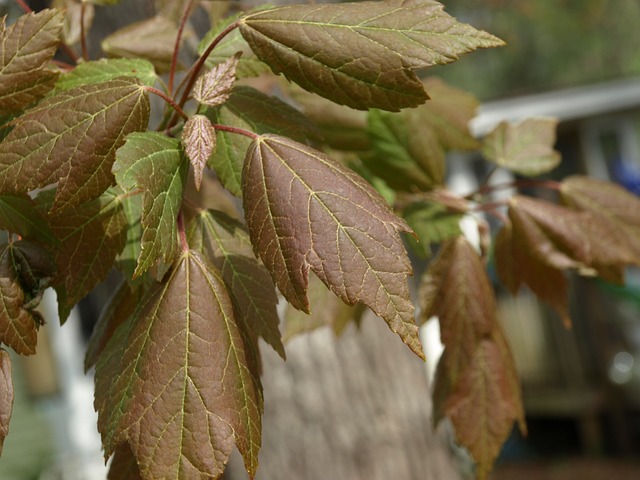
[242,135,423,357]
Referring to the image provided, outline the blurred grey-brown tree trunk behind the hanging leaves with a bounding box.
[227,317,460,480]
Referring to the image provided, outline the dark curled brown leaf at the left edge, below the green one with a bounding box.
[0,240,54,355]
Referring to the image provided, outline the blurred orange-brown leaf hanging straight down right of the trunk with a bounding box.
[420,237,526,478]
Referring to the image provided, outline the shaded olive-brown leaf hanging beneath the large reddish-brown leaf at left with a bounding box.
[36,190,127,322]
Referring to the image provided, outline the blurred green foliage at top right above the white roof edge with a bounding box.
[438,0,640,100]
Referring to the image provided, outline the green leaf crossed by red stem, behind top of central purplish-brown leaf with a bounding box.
[206,86,318,197]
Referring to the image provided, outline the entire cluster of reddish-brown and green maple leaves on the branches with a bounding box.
[0,0,640,479]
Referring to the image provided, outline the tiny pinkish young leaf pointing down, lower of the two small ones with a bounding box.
[182,115,216,190]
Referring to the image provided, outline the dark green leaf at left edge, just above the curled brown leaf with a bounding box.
[0,195,58,244]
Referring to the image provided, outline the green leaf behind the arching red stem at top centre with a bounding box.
[198,15,270,78]
